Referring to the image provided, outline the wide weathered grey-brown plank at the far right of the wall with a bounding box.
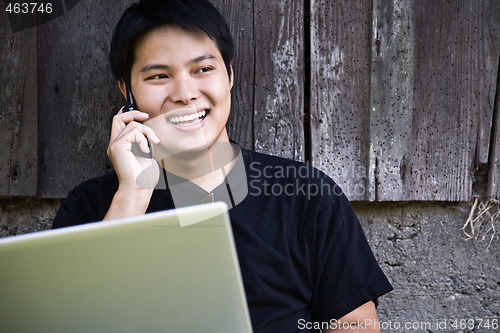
[409,0,498,201]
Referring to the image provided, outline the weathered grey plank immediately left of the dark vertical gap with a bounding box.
[253,0,304,161]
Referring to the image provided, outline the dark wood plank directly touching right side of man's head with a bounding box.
[212,0,255,149]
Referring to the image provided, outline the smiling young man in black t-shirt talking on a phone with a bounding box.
[54,0,392,333]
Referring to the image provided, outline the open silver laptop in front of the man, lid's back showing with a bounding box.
[0,203,252,333]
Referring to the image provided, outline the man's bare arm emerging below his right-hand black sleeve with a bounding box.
[325,301,380,333]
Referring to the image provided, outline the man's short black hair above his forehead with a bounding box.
[109,0,234,80]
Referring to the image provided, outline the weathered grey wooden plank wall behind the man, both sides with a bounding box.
[0,0,500,201]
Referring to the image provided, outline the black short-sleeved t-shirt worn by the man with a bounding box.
[53,149,392,333]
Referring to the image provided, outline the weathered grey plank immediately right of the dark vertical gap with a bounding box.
[311,0,372,200]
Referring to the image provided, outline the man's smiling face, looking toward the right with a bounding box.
[122,26,233,153]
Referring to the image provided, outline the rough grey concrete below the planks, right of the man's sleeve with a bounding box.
[353,202,500,332]
